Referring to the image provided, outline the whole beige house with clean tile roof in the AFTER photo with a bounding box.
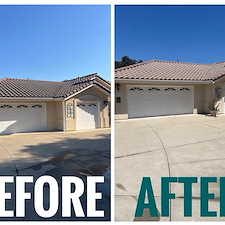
[115,60,225,119]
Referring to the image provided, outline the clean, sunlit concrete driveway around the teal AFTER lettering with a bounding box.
[115,115,225,221]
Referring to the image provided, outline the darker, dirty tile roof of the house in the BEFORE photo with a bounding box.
[0,73,110,98]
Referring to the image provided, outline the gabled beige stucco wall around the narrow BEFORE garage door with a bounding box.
[65,87,109,131]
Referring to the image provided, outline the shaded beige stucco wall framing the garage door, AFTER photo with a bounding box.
[115,83,205,119]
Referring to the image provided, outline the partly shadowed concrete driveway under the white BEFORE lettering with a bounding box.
[0,129,110,220]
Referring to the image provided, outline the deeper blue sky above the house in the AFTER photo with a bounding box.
[115,5,225,63]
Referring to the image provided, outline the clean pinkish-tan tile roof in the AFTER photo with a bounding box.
[115,59,225,81]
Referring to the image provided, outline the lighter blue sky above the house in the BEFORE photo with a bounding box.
[0,5,110,81]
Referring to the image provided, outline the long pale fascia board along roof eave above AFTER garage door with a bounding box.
[115,78,212,84]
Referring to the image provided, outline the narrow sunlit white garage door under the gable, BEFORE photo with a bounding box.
[77,102,99,130]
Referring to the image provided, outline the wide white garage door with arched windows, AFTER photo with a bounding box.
[127,85,194,118]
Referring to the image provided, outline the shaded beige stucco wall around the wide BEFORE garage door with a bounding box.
[0,100,61,131]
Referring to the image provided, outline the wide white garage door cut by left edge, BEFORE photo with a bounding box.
[0,103,46,134]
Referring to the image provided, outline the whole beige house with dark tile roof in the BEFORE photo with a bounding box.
[0,74,110,134]
